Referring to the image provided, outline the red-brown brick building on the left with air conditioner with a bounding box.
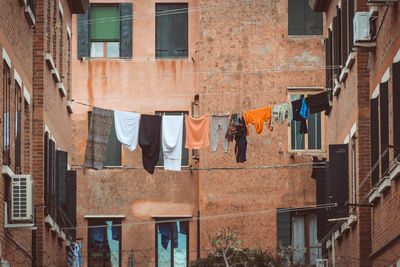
[0,0,87,266]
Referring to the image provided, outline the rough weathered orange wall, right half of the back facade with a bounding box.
[199,0,326,254]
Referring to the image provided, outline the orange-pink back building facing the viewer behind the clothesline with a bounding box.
[71,0,327,266]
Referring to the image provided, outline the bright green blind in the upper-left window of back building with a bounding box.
[90,6,120,41]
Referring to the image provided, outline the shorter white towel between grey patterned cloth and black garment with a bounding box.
[114,110,140,151]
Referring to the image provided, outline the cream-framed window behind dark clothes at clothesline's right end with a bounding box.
[289,93,323,151]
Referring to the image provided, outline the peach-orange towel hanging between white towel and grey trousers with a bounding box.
[185,115,210,149]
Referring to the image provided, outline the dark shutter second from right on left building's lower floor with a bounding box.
[56,150,68,227]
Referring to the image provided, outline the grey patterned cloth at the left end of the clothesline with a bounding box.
[85,108,114,170]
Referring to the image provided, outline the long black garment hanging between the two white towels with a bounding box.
[139,115,161,174]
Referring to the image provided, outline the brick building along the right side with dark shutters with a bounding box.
[310,0,400,266]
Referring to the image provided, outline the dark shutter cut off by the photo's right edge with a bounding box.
[392,62,400,157]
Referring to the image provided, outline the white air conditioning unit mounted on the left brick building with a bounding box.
[11,175,34,221]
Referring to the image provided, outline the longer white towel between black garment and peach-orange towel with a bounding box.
[161,116,183,171]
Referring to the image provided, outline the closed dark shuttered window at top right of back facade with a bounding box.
[288,0,322,35]
